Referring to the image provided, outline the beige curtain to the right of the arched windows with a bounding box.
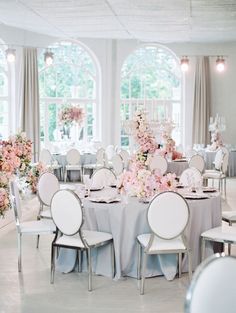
[193,56,211,145]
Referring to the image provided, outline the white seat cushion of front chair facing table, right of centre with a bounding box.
[137,234,186,252]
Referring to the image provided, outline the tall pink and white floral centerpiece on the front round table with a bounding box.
[118,111,176,199]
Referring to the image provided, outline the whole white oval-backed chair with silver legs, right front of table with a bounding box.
[137,191,192,294]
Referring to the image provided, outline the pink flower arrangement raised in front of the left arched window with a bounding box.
[59,106,84,125]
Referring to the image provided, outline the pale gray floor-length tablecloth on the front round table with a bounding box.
[57,194,221,280]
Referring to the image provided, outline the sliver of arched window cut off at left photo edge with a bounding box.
[0,46,10,140]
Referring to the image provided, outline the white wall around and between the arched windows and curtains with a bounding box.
[0,25,236,145]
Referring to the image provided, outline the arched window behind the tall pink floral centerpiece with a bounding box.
[120,45,182,147]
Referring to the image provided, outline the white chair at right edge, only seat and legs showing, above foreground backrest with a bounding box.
[201,225,236,260]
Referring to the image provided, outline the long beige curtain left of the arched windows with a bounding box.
[20,48,40,162]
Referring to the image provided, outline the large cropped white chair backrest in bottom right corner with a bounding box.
[185,254,236,313]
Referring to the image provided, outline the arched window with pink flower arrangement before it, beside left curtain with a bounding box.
[39,41,99,146]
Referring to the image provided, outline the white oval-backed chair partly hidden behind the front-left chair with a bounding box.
[37,172,60,219]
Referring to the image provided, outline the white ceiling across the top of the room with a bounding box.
[0,0,236,43]
